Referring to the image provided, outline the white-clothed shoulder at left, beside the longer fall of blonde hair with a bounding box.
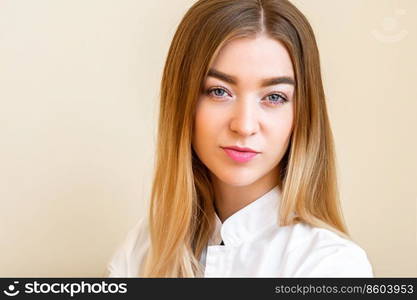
[106,217,149,277]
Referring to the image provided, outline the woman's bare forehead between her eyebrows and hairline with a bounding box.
[207,35,294,80]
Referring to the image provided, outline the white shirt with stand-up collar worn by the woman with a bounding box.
[107,186,373,277]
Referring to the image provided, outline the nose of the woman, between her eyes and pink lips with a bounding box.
[230,98,259,136]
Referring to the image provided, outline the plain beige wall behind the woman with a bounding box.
[0,0,417,277]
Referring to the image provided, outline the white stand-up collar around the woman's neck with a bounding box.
[208,185,281,246]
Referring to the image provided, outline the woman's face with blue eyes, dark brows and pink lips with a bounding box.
[192,36,295,186]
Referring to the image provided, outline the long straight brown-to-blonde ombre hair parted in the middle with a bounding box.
[140,0,349,277]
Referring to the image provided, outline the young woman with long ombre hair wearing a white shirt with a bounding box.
[107,0,373,277]
